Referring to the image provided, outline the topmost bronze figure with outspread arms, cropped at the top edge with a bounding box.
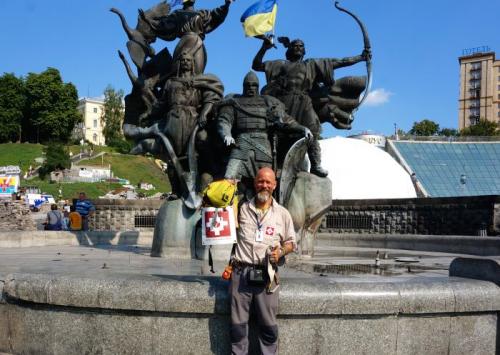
[139,0,232,74]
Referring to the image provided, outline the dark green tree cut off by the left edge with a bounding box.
[0,73,26,143]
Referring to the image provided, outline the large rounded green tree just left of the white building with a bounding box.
[23,68,81,143]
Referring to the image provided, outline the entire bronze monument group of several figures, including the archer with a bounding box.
[111,0,371,257]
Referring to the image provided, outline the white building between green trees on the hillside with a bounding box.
[76,97,106,145]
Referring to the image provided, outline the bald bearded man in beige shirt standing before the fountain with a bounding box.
[230,168,296,354]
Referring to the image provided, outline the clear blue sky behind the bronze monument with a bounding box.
[0,0,500,136]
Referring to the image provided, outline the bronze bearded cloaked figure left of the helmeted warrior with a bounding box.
[123,52,224,202]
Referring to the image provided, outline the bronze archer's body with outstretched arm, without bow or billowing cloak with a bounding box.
[252,37,371,177]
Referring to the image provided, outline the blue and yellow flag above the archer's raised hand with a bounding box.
[241,0,278,37]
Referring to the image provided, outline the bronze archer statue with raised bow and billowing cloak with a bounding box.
[252,3,371,177]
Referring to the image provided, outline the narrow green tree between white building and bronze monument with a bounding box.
[101,85,124,146]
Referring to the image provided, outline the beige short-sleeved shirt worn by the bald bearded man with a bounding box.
[234,199,296,265]
